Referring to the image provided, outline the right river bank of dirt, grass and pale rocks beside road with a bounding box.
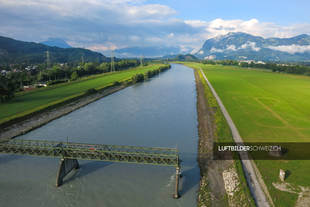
[193,64,254,207]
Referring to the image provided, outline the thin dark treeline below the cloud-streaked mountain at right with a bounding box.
[203,60,310,76]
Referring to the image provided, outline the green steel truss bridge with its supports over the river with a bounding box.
[0,139,180,198]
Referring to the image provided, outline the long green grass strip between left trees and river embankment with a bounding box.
[0,64,163,124]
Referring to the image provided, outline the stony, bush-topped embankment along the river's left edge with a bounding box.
[0,65,171,139]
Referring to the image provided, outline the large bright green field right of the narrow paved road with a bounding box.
[186,63,310,207]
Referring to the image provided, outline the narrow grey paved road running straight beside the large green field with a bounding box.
[200,68,270,207]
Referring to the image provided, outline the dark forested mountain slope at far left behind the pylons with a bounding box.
[0,36,107,65]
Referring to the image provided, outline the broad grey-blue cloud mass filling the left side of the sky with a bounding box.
[0,0,194,51]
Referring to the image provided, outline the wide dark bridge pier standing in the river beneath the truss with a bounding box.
[56,158,80,187]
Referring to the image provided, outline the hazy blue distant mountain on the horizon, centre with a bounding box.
[115,46,181,57]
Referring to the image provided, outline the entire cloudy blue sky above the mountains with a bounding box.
[0,0,310,53]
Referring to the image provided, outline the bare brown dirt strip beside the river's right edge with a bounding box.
[195,71,231,206]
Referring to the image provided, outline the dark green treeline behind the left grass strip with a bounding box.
[0,60,145,102]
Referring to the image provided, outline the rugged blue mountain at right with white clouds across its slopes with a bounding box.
[195,32,310,62]
